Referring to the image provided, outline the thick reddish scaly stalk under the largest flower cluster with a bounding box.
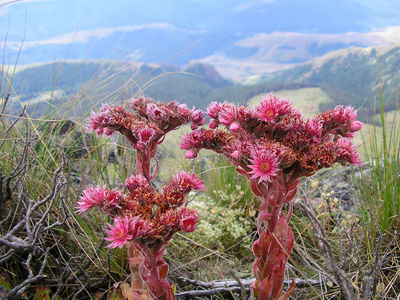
[251,171,298,299]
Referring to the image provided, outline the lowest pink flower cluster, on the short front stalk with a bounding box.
[77,171,205,248]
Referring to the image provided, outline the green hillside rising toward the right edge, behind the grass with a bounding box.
[264,45,400,119]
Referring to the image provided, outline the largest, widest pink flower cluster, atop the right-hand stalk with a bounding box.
[180,93,362,181]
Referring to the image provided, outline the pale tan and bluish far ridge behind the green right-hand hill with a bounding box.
[201,27,400,82]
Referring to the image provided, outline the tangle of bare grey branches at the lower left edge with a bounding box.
[0,118,66,299]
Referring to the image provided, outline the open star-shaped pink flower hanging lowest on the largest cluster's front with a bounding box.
[249,150,278,183]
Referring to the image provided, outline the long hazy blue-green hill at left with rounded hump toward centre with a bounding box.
[2,60,317,118]
